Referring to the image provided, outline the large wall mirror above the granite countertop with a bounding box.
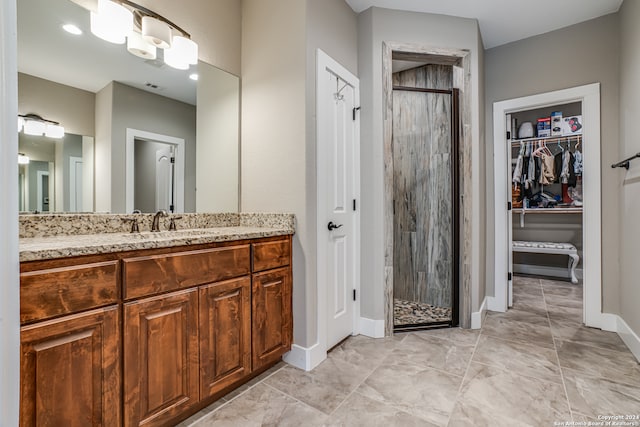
[18,0,240,213]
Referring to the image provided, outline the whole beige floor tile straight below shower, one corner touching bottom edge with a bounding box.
[357,362,462,426]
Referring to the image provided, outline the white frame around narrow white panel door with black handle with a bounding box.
[312,49,361,367]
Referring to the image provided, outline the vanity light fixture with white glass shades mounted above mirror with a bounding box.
[84,0,198,70]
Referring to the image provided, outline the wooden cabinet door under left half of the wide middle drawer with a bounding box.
[124,289,198,427]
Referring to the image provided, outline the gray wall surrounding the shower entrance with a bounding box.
[358,8,484,320]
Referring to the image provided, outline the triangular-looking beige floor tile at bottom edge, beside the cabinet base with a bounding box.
[192,384,327,427]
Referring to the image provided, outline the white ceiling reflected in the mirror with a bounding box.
[17,0,196,105]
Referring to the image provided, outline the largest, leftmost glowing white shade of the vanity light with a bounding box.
[91,0,133,44]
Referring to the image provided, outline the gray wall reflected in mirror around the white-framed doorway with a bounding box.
[109,82,196,212]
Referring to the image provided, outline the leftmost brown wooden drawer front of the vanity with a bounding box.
[20,261,119,323]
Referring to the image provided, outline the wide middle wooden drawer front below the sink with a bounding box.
[123,245,250,299]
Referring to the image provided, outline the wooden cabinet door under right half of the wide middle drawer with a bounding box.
[199,276,251,399]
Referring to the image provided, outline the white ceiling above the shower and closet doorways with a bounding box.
[346,0,623,49]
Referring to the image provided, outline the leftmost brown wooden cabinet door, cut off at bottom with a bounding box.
[20,306,121,427]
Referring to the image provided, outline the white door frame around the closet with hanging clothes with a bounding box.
[487,83,610,329]
